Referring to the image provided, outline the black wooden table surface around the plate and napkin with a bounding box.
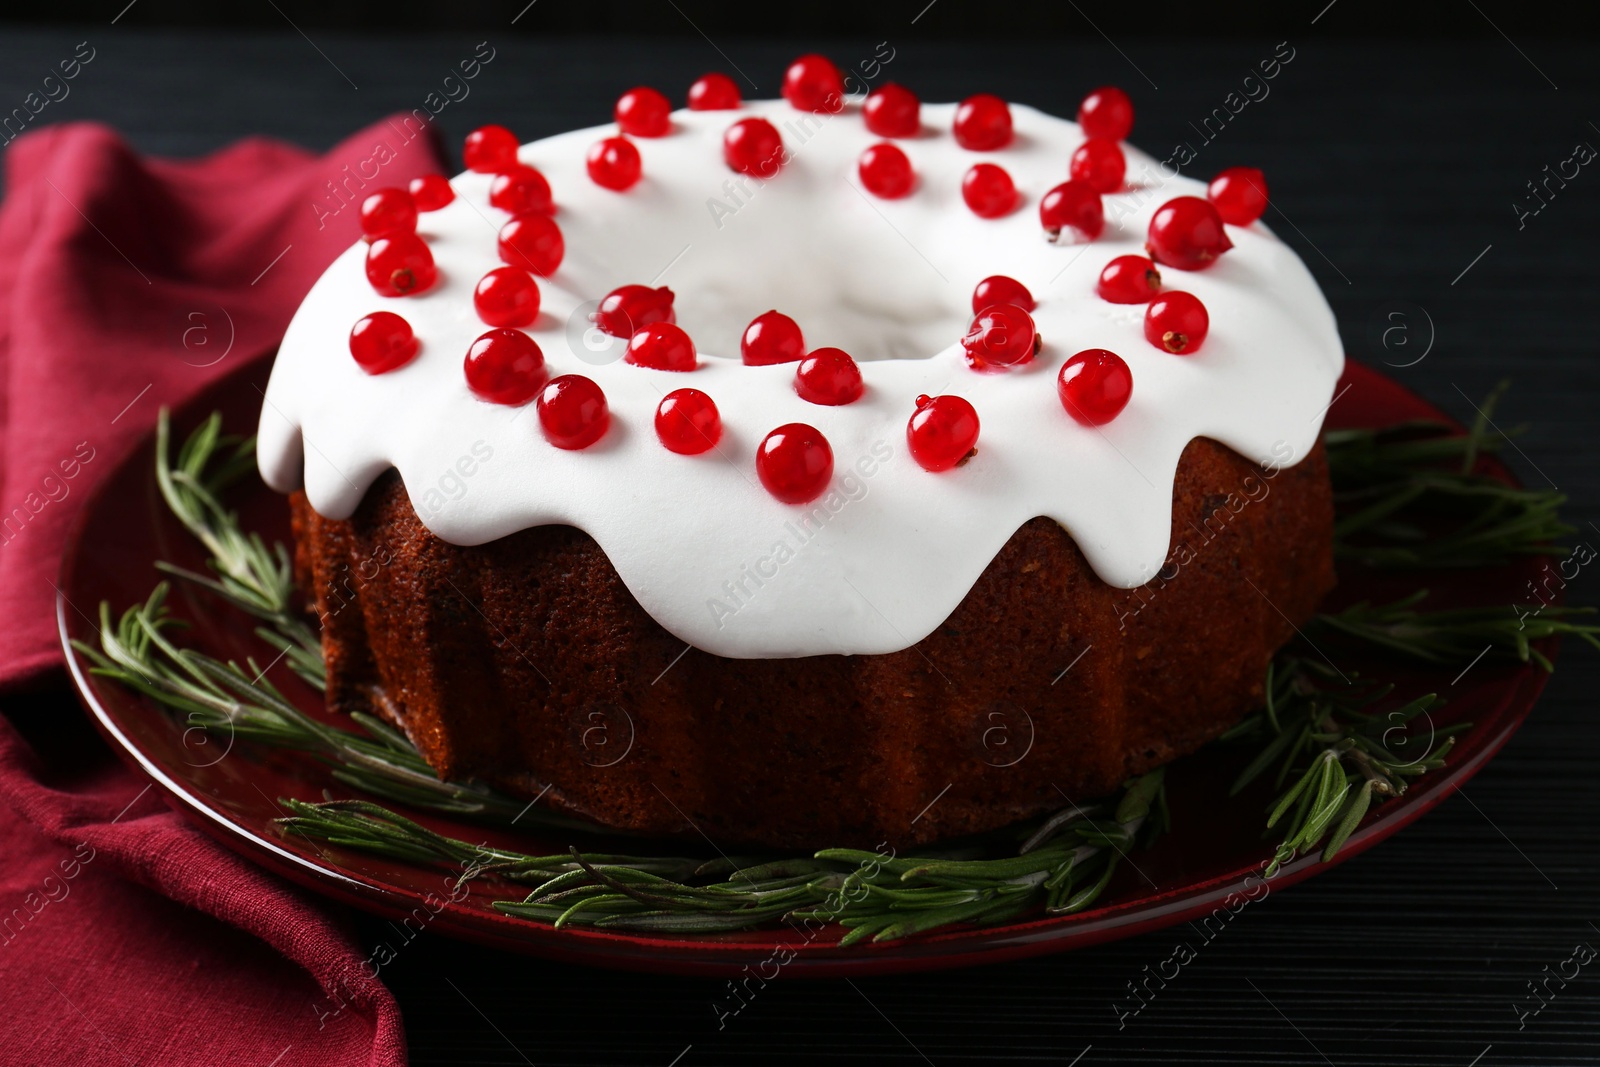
[0,20,1600,1067]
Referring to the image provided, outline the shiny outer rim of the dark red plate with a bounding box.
[56,354,1558,977]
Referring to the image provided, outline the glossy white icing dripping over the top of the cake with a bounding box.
[259,101,1344,657]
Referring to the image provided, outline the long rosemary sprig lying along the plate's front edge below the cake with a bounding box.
[280,769,1165,945]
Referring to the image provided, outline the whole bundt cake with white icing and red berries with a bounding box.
[259,66,1342,848]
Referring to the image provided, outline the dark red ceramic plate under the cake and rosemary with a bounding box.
[58,362,1555,976]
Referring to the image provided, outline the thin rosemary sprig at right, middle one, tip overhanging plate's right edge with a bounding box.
[1314,589,1600,670]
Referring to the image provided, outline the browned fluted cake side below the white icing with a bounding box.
[293,440,1334,848]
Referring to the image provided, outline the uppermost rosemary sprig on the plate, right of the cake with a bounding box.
[1323,382,1574,568]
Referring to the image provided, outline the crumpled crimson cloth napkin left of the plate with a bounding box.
[0,116,440,1067]
